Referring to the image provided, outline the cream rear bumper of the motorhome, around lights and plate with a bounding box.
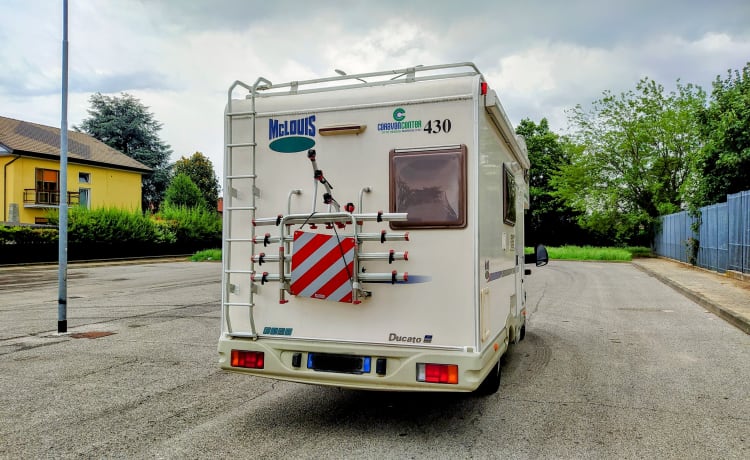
[219,335,508,392]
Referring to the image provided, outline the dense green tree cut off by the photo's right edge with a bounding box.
[691,63,750,208]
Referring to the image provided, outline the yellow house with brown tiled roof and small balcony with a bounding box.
[0,116,151,225]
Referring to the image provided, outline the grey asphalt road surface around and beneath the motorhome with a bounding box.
[0,261,750,459]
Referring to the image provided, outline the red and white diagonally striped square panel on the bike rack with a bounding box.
[290,230,354,302]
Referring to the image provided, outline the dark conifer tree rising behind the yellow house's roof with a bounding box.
[73,93,172,210]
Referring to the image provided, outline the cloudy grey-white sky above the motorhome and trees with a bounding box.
[0,0,750,183]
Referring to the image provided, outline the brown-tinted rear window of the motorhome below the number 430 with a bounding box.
[390,145,466,228]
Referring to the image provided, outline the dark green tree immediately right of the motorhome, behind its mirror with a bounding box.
[516,118,593,246]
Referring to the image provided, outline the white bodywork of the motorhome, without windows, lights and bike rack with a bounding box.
[219,63,528,391]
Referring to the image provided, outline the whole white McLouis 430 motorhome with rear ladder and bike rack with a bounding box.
[218,63,546,393]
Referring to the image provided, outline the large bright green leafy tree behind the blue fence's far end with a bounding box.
[552,78,706,244]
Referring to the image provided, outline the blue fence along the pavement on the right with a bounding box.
[654,191,750,273]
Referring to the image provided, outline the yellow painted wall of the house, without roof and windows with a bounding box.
[0,157,141,224]
